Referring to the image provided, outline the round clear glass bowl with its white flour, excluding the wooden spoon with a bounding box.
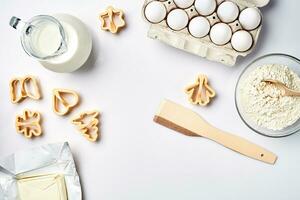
[235,54,300,137]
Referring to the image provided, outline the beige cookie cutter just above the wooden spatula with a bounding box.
[185,74,216,106]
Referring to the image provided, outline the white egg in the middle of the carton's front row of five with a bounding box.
[189,16,210,38]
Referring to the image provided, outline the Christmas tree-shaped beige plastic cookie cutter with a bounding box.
[72,111,99,142]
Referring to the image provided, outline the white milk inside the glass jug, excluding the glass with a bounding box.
[36,14,92,72]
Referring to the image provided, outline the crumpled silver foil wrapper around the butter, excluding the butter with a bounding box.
[0,143,82,200]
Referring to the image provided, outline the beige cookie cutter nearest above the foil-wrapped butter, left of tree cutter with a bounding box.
[15,109,42,138]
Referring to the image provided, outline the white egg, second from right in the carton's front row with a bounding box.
[210,23,232,45]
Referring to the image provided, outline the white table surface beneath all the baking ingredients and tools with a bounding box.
[0,0,300,200]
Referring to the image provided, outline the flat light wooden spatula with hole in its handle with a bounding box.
[154,100,277,164]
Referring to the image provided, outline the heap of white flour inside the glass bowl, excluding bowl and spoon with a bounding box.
[239,64,300,130]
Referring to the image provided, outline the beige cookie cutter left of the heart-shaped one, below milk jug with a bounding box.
[9,75,41,103]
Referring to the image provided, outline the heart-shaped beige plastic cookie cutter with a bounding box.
[52,88,79,116]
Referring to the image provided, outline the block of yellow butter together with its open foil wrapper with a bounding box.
[0,143,82,200]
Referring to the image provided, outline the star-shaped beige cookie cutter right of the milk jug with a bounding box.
[99,6,126,33]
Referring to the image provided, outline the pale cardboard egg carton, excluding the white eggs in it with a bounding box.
[142,0,269,66]
